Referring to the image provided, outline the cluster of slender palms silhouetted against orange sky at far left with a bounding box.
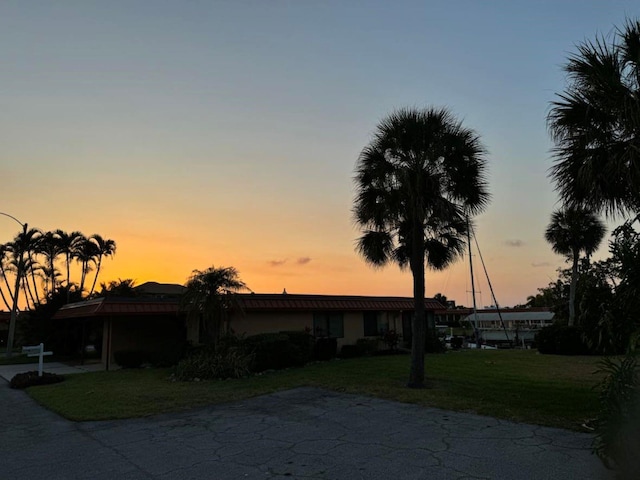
[0,228,116,309]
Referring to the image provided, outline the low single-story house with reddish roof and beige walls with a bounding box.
[54,293,442,370]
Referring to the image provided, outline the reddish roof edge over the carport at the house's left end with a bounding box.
[53,297,178,320]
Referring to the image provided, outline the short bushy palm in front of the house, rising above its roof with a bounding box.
[182,266,248,344]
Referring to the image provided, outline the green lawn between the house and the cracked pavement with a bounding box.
[28,350,599,430]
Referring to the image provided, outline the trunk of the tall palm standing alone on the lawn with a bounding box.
[407,220,426,388]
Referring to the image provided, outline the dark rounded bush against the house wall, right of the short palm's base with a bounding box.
[244,333,309,372]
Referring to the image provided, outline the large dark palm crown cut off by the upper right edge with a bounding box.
[547,20,640,215]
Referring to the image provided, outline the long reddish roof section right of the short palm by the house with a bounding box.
[238,293,442,311]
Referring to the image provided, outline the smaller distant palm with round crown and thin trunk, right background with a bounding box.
[544,207,606,326]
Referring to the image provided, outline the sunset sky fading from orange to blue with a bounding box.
[0,0,640,306]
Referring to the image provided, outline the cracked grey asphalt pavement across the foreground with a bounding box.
[0,385,613,480]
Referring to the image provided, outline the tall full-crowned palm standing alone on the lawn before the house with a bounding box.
[353,108,489,388]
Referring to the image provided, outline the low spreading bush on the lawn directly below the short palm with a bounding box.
[176,346,253,380]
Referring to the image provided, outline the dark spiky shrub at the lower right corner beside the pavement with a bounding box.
[593,355,640,479]
